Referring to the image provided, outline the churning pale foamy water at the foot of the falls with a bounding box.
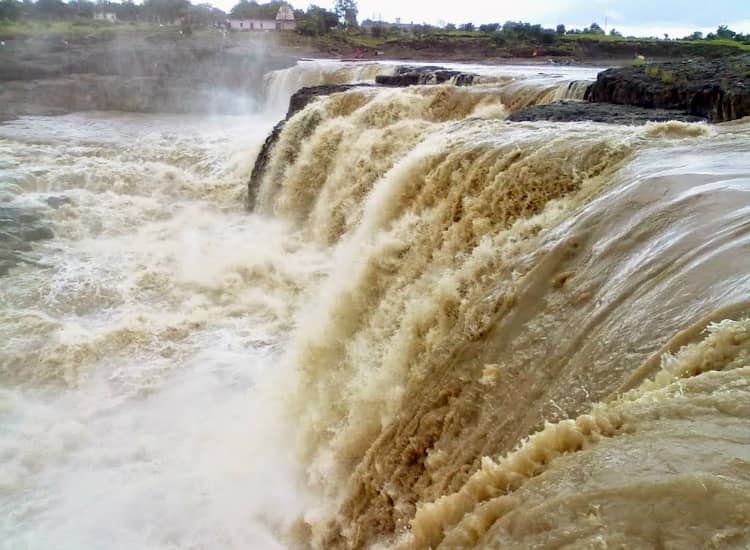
[0,114,328,549]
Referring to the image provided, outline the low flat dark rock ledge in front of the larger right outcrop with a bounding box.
[508,101,706,125]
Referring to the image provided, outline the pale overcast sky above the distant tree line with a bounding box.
[234,0,750,37]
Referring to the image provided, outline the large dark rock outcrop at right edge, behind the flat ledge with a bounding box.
[586,54,750,122]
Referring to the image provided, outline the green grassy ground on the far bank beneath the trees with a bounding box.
[0,20,750,60]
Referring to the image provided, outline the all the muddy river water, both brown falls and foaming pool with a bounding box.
[0,58,750,550]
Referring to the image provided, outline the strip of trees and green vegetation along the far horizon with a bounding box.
[0,0,750,58]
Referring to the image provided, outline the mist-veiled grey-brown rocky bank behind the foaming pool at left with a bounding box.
[0,31,296,119]
